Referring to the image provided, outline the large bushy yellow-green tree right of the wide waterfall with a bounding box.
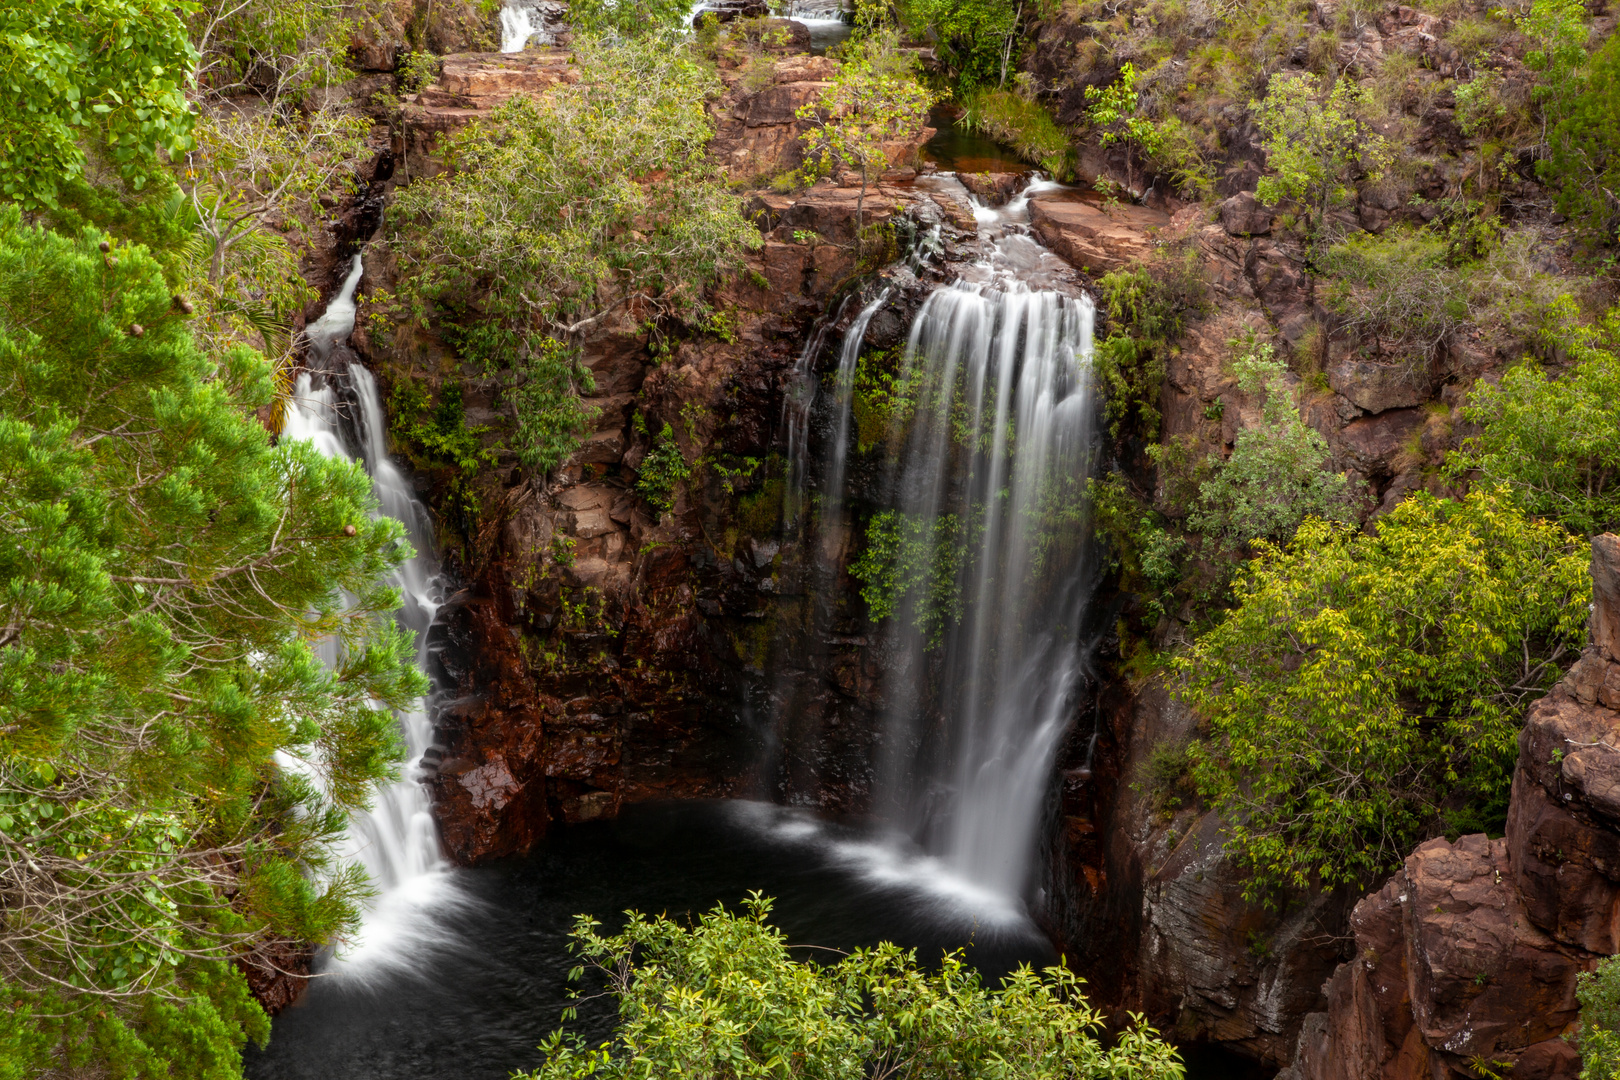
[1175,489,1591,897]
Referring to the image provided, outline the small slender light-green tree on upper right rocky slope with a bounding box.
[1249,71,1390,264]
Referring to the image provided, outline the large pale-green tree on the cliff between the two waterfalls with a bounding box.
[389,36,760,468]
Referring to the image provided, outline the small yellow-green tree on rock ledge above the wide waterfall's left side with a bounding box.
[799,31,935,254]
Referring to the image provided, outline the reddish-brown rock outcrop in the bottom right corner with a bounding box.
[1285,536,1620,1080]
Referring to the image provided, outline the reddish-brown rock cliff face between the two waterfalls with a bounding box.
[343,39,946,863]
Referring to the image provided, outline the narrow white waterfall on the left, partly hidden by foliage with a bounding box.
[282,254,452,973]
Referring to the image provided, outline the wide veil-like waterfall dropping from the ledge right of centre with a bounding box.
[823,181,1095,897]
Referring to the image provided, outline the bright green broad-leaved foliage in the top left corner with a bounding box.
[0,0,196,209]
